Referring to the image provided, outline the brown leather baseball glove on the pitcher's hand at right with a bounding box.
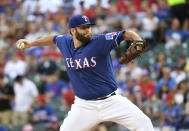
[119,40,146,64]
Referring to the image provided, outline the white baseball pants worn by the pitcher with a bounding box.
[60,94,154,131]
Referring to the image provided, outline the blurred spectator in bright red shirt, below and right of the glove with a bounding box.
[138,70,155,98]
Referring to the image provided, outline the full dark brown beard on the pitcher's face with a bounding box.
[76,29,92,45]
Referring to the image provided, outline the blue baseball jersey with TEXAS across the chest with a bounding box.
[54,31,124,100]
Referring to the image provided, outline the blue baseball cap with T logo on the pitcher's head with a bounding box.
[69,15,94,28]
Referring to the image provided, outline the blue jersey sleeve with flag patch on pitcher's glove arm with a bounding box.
[99,31,125,52]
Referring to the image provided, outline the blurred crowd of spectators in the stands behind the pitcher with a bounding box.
[0,0,189,131]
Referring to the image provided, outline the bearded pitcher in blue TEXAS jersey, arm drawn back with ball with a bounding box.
[16,15,154,131]
